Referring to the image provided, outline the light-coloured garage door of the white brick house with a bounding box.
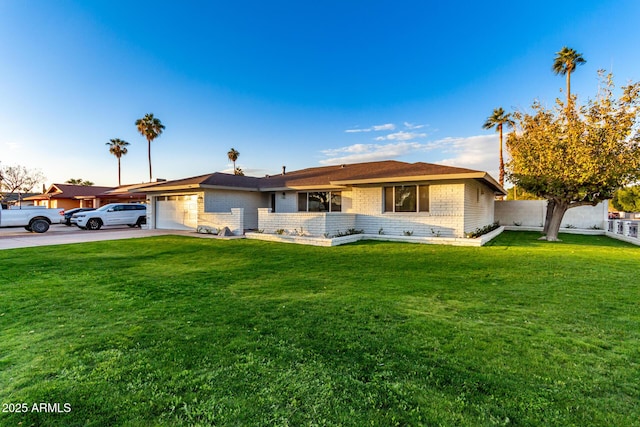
[156,194,198,230]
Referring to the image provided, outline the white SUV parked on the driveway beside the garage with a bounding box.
[72,203,147,230]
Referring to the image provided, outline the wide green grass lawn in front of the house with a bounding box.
[0,232,640,426]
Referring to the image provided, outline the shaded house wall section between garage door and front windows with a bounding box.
[205,190,269,230]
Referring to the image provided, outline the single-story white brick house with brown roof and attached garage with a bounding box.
[144,161,506,237]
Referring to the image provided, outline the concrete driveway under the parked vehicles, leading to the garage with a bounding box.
[0,224,192,250]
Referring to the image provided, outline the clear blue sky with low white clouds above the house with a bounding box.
[0,0,640,185]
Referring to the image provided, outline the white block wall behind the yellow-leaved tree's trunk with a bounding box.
[495,200,609,229]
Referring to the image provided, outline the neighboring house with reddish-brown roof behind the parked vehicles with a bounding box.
[24,184,148,210]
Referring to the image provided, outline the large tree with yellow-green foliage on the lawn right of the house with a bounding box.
[507,73,640,241]
